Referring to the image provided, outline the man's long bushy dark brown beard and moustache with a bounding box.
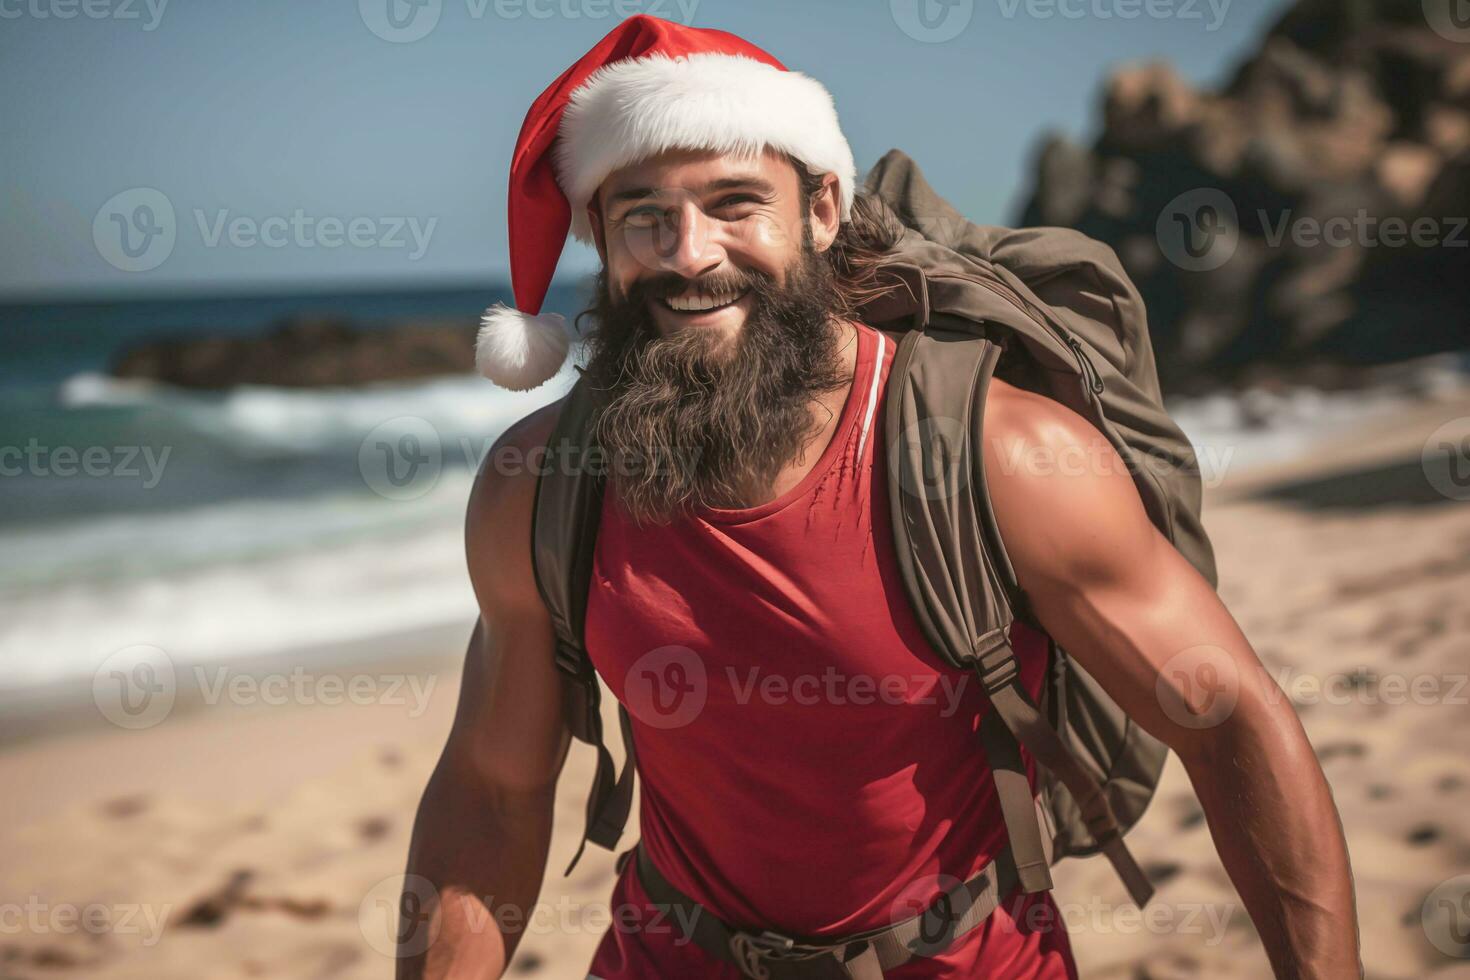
[584,239,850,525]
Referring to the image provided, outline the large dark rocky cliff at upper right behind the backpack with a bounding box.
[1020,0,1470,389]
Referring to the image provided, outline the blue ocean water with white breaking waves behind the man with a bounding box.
[0,291,1470,695]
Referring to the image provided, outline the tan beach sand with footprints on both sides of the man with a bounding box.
[0,398,1470,980]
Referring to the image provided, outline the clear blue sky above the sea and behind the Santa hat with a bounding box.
[0,0,1280,300]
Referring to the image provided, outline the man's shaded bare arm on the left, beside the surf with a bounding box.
[397,406,569,980]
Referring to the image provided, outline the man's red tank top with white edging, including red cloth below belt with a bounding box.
[587,325,1070,979]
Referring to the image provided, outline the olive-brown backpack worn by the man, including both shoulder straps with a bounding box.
[532,150,1216,907]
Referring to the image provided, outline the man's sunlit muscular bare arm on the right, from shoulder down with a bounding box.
[985,382,1361,980]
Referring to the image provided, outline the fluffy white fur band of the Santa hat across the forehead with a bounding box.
[553,54,857,241]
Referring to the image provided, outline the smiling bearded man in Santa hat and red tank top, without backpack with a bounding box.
[400,18,1360,979]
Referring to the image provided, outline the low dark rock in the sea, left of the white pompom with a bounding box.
[112,317,475,388]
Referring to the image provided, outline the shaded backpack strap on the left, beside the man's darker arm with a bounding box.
[531,379,637,874]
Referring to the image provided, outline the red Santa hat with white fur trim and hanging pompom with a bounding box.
[476,15,857,391]
